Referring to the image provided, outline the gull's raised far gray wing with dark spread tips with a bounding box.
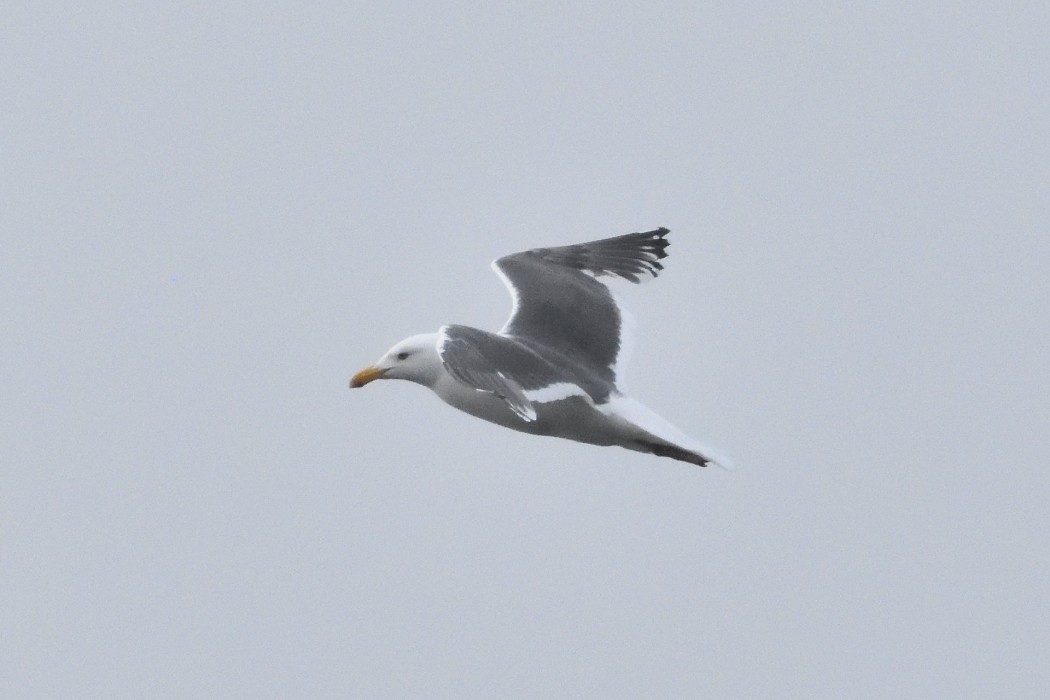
[494,228,670,384]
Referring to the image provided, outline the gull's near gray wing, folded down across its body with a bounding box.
[438,325,565,421]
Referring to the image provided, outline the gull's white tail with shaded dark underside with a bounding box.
[597,396,733,469]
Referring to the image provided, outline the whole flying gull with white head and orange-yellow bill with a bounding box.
[350,229,730,468]
